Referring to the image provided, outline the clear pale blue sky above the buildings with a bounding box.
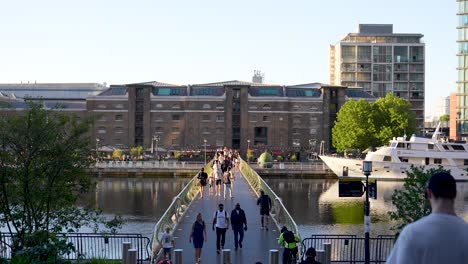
[0,0,457,115]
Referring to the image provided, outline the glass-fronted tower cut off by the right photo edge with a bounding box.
[458,0,468,140]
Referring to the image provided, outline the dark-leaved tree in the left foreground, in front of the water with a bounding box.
[0,102,122,258]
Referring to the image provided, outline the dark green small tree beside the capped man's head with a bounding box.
[389,166,450,232]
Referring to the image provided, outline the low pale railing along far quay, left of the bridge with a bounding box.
[94,160,204,169]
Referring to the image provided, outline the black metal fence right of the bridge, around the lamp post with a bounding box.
[302,235,395,263]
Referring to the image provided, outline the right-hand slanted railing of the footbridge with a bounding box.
[240,160,301,258]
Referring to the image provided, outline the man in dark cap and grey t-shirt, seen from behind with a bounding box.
[387,172,468,264]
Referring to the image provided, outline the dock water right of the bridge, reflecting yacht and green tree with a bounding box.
[266,179,468,236]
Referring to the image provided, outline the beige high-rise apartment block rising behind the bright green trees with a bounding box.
[330,24,425,131]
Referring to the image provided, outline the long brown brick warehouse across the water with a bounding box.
[0,81,375,152]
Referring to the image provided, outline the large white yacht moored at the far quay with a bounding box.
[320,124,468,181]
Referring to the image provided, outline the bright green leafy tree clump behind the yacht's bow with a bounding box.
[332,94,415,153]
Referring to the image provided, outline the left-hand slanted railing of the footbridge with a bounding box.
[149,162,212,256]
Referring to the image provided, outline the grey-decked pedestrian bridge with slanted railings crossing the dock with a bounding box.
[150,161,298,263]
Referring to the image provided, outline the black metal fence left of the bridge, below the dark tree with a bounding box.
[0,233,150,263]
